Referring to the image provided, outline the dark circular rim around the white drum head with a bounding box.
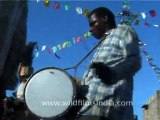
[23,67,76,119]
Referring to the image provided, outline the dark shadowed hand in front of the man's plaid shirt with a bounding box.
[90,62,113,84]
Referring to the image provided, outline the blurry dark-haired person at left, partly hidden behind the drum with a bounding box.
[13,42,37,120]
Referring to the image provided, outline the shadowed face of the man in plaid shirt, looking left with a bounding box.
[88,14,106,39]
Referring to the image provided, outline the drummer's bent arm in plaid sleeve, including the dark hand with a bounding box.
[90,26,141,84]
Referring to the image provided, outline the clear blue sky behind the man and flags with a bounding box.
[6,0,160,120]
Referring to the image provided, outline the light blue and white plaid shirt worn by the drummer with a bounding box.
[81,25,141,117]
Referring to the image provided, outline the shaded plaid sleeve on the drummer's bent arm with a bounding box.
[110,26,141,81]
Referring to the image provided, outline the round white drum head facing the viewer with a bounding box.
[24,68,76,118]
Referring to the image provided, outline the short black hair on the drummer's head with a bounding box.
[88,7,116,26]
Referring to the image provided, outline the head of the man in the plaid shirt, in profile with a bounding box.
[88,7,116,39]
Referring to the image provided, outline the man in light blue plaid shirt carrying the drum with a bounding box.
[78,7,141,120]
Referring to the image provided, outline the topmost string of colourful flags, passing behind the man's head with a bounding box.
[40,0,160,27]
